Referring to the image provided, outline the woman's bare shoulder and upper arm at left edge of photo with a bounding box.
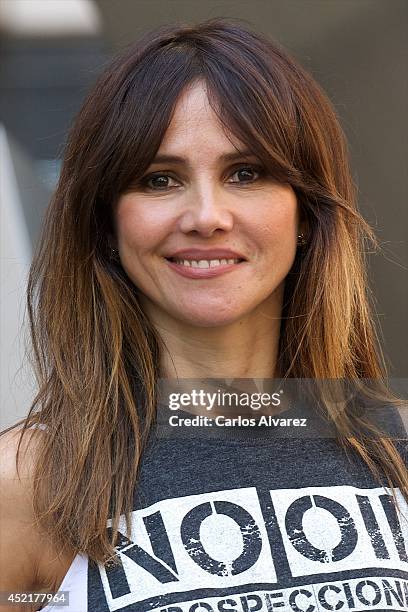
[0,429,73,591]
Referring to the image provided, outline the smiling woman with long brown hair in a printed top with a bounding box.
[2,20,408,612]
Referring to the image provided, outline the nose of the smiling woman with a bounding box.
[179,185,234,237]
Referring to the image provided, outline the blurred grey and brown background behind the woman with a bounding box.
[0,0,408,428]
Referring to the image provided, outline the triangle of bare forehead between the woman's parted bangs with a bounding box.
[159,81,242,154]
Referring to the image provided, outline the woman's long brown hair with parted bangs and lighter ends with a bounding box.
[7,20,408,562]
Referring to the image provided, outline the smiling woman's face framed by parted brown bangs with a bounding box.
[115,83,299,327]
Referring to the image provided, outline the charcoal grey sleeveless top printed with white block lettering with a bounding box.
[42,406,408,612]
